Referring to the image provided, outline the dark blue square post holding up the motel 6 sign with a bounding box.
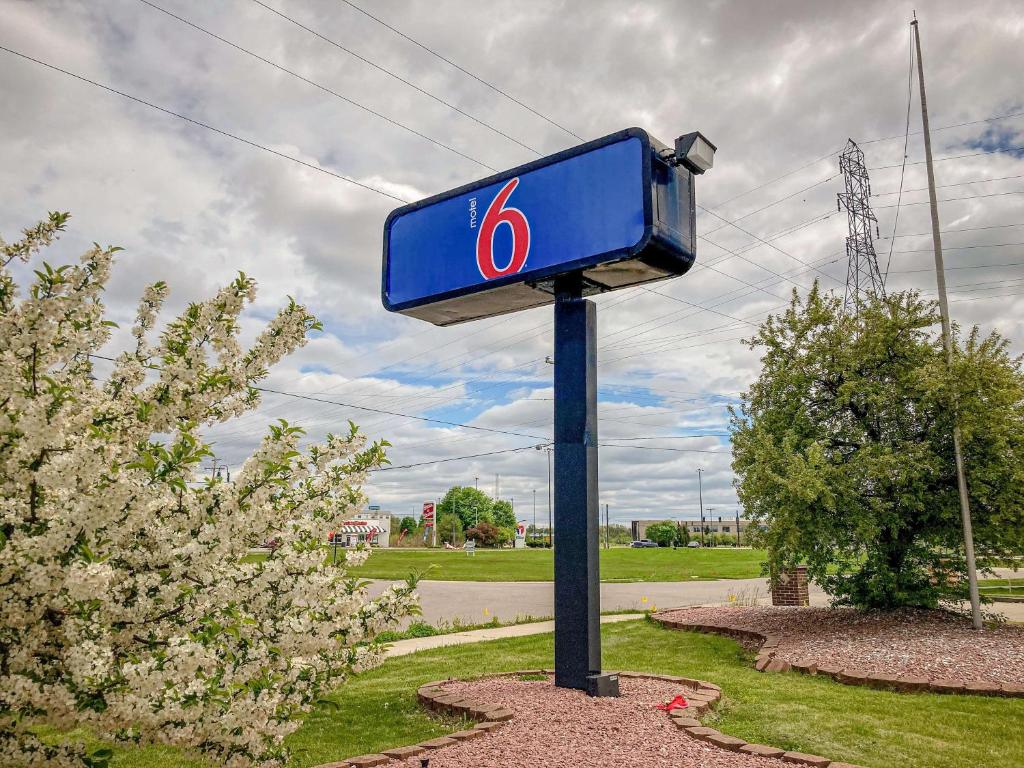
[554,273,601,693]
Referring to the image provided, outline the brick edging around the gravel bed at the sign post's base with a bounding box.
[315,670,859,768]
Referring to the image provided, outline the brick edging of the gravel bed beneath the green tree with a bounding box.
[651,608,1024,698]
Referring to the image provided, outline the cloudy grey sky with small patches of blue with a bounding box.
[0,0,1024,522]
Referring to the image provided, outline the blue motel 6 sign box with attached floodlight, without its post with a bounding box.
[382,128,714,326]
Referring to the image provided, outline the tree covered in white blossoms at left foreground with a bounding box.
[0,214,416,766]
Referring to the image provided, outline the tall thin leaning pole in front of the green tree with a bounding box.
[910,12,982,630]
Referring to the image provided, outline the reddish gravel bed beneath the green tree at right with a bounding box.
[659,606,1024,684]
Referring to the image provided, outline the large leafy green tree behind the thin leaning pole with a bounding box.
[732,286,1024,608]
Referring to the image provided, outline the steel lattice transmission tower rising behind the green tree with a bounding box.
[837,138,886,313]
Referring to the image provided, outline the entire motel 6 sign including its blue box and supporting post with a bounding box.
[382,128,715,695]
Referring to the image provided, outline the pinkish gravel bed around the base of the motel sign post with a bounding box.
[388,678,779,768]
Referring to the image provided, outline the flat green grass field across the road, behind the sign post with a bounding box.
[342,548,764,582]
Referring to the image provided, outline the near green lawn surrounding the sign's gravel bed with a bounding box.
[97,621,1024,768]
